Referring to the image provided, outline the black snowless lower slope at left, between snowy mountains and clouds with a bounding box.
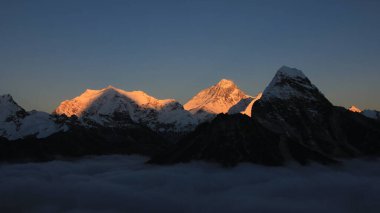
[0,126,170,162]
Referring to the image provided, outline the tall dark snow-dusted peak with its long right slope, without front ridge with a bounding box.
[252,67,380,157]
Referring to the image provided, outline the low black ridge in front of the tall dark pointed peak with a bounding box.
[149,114,336,166]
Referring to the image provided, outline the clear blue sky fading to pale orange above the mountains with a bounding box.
[0,0,380,112]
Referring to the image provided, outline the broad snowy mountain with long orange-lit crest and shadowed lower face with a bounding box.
[54,86,197,133]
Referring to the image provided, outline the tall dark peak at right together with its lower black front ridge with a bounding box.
[151,67,380,166]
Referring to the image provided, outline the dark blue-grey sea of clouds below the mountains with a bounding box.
[0,156,380,213]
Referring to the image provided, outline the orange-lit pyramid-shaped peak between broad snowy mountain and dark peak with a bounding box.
[184,79,252,121]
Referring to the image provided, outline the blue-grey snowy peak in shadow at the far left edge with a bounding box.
[0,95,67,140]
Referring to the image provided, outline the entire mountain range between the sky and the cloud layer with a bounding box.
[0,66,380,166]
